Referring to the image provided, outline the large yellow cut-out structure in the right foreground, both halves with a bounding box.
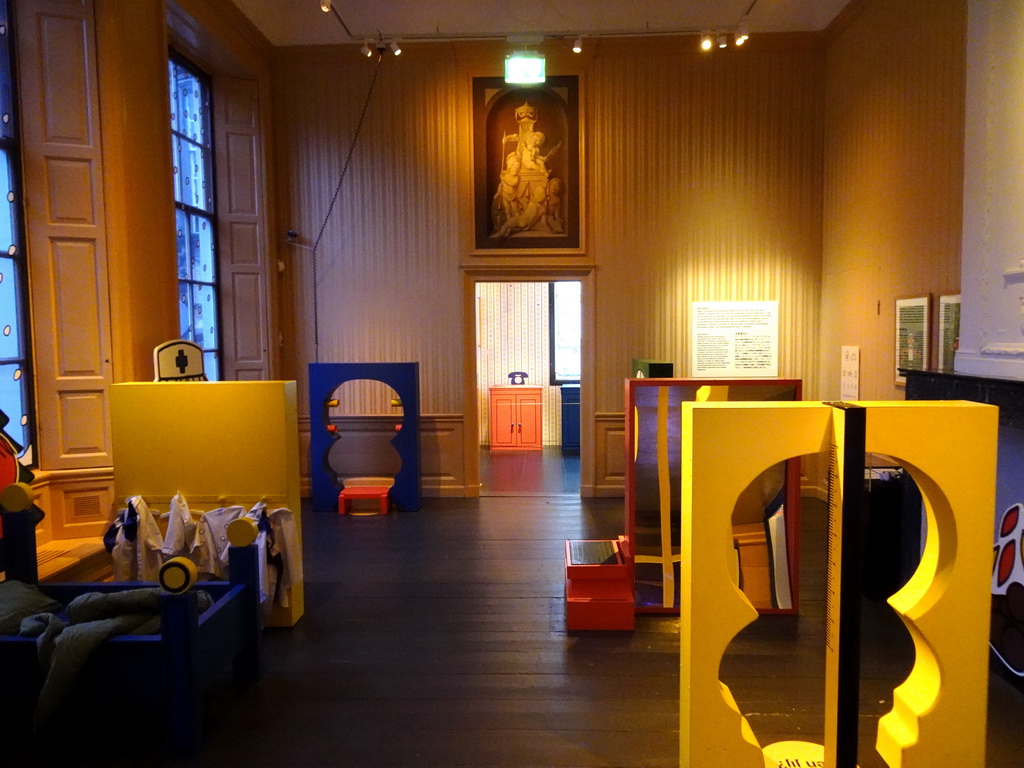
[680,401,998,768]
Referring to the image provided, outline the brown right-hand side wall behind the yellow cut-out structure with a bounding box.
[811,0,967,399]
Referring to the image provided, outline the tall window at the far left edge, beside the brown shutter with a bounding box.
[0,0,35,465]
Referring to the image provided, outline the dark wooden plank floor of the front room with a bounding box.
[8,473,1024,768]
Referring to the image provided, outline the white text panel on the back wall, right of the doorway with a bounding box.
[690,301,778,379]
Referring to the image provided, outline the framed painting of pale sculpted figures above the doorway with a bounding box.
[473,76,581,253]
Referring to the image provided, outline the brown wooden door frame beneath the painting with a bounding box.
[462,264,595,497]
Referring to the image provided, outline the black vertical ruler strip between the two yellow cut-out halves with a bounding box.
[833,403,867,768]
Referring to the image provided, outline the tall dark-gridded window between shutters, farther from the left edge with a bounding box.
[169,56,220,381]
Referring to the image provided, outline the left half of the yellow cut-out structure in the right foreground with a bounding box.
[679,402,830,768]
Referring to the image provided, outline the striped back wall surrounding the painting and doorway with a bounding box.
[274,36,823,494]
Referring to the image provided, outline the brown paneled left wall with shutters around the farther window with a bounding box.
[13,0,279,542]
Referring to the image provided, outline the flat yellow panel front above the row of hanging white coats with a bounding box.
[111,381,303,626]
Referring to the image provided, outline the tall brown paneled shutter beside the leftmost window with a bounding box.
[17,2,113,470]
